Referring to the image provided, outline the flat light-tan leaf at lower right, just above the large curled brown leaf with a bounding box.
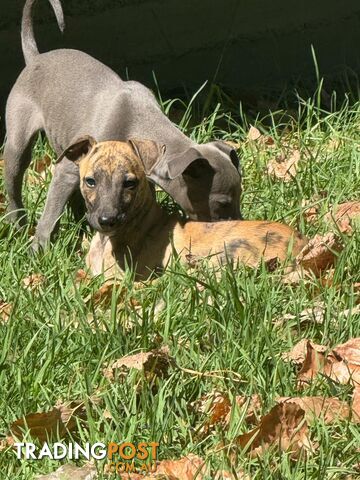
[276,396,360,424]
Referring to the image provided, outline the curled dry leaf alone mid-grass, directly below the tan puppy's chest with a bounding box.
[104,346,173,381]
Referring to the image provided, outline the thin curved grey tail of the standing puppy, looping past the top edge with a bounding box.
[21,0,65,65]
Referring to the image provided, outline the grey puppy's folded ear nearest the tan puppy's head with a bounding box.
[167,147,214,180]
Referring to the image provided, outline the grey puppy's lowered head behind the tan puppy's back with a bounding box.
[149,141,242,221]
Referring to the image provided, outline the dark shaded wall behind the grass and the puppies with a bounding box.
[0,0,360,112]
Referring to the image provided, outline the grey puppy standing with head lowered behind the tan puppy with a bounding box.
[4,0,241,249]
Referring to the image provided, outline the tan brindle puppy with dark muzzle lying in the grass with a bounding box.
[58,138,307,279]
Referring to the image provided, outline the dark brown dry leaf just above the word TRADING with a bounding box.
[10,402,84,442]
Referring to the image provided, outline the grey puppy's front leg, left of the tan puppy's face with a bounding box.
[32,158,79,252]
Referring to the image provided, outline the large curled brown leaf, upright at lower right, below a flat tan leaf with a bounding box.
[234,402,312,458]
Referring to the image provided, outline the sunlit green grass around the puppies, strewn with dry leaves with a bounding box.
[0,93,360,480]
